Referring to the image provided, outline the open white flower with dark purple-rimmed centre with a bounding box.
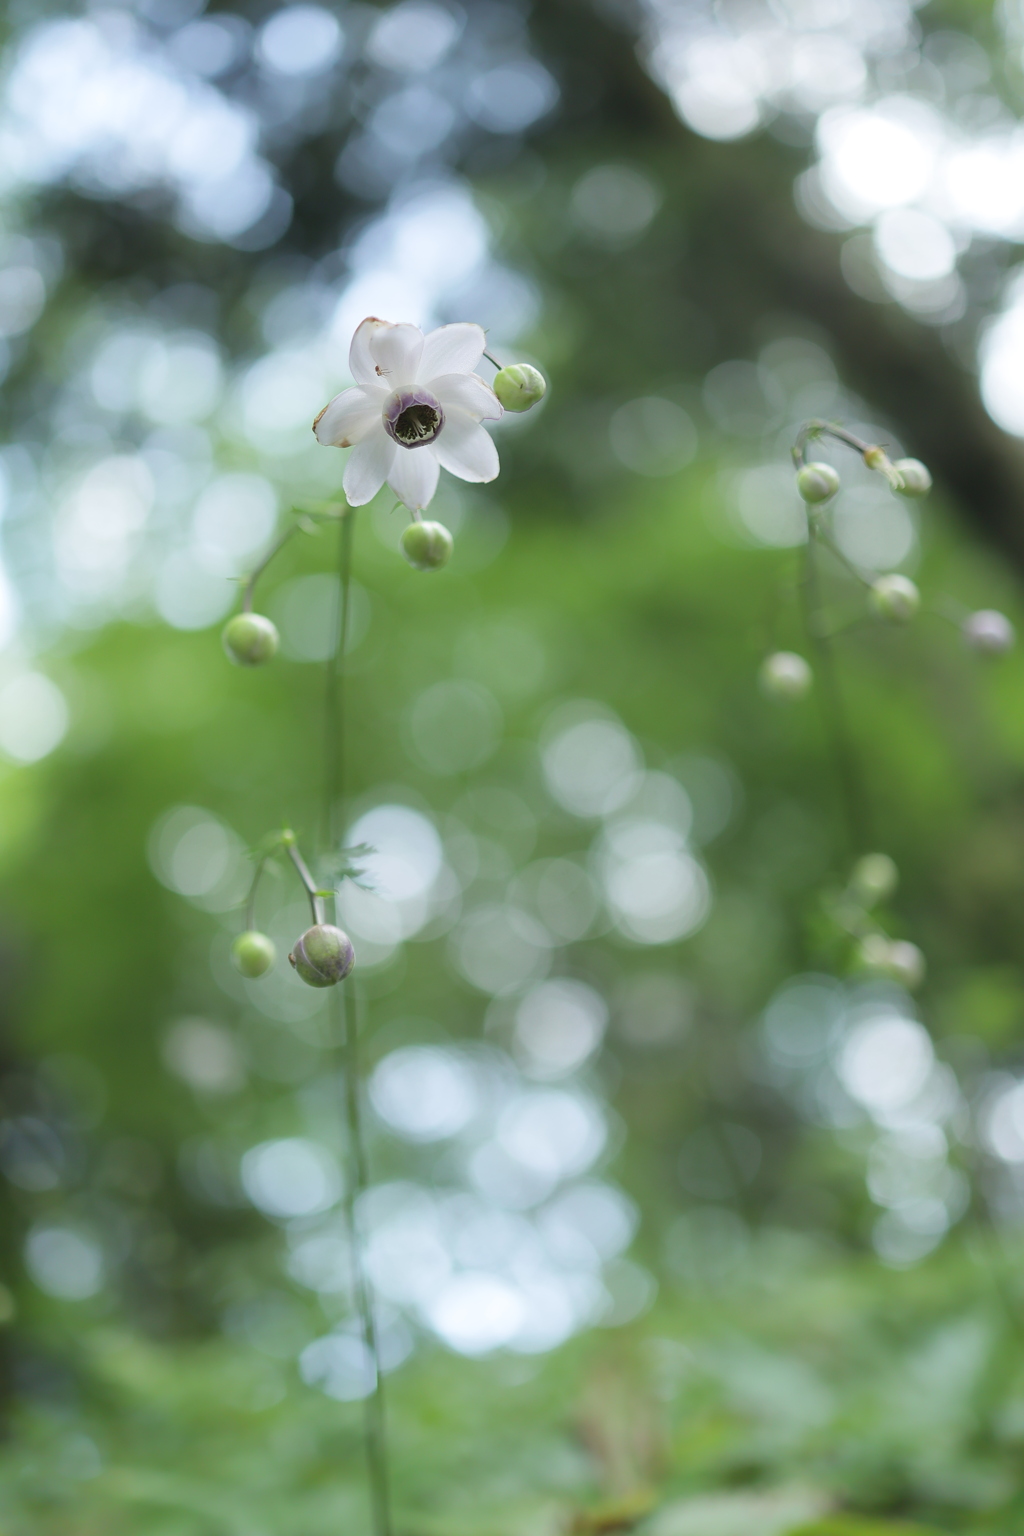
[313,318,502,510]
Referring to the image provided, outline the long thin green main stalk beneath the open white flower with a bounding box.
[321,508,391,1536]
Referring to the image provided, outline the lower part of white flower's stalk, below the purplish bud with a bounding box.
[335,982,391,1536]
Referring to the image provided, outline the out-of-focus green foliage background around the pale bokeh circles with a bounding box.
[0,0,1024,1536]
